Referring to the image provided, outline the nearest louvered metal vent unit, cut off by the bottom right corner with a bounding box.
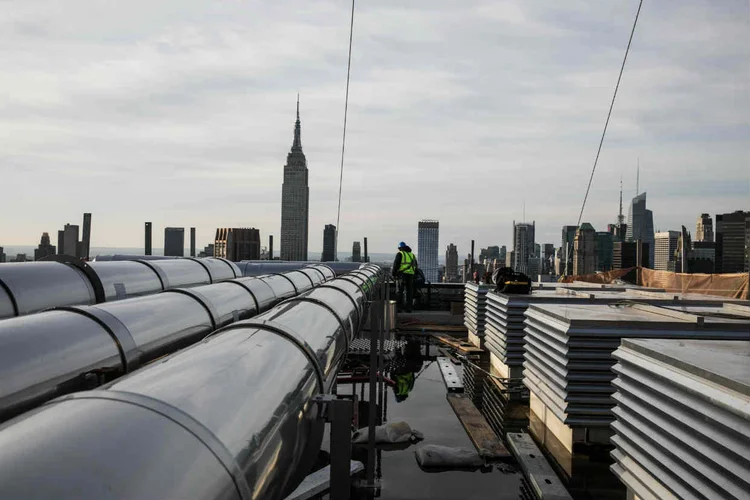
[611,339,750,499]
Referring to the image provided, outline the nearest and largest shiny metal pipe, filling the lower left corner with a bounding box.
[0,270,378,500]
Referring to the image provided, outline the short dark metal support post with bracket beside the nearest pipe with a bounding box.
[312,394,353,500]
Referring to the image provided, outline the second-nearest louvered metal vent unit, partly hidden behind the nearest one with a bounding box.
[523,303,750,427]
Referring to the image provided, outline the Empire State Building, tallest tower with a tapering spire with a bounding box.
[281,95,310,260]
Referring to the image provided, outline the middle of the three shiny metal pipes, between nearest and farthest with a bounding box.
[0,268,336,422]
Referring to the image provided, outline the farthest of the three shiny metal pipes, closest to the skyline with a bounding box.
[0,256,242,320]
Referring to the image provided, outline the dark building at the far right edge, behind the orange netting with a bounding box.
[716,210,750,273]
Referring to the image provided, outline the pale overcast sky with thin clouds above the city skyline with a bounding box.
[0,0,750,254]
